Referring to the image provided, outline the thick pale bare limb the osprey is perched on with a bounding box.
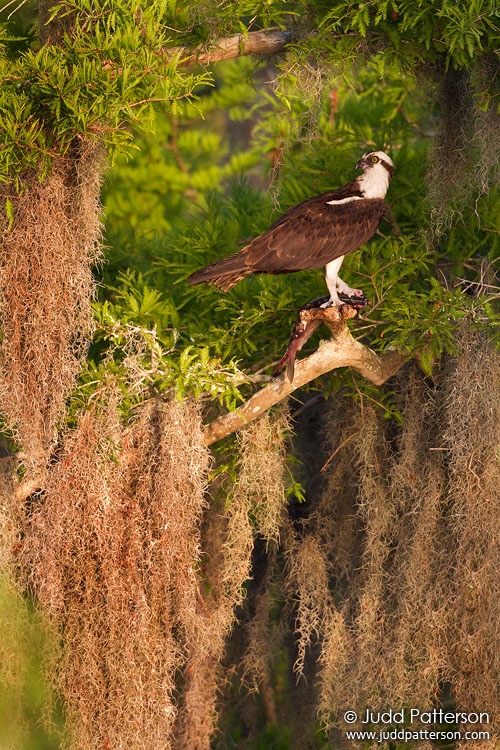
[205,323,405,445]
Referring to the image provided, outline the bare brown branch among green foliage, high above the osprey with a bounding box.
[168,28,292,67]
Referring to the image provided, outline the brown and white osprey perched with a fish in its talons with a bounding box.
[188,151,394,306]
